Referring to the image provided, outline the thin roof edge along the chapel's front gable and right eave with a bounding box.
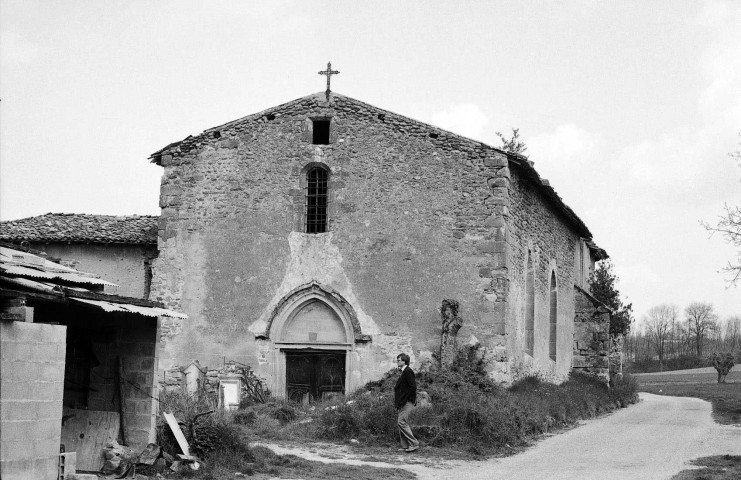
[149,92,607,258]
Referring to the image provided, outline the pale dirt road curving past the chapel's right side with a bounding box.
[258,393,741,480]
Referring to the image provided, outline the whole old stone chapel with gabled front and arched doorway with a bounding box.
[150,90,608,398]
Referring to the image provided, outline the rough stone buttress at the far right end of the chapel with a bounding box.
[573,287,611,383]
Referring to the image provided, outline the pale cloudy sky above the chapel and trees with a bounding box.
[0,0,741,318]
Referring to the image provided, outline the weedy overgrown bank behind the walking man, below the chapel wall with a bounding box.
[240,347,637,455]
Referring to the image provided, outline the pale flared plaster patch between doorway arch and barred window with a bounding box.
[249,232,381,335]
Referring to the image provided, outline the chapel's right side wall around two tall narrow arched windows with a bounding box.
[506,167,581,379]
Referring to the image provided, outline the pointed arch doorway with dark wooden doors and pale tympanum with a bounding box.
[268,284,367,401]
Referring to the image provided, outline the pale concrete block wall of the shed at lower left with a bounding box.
[0,321,66,480]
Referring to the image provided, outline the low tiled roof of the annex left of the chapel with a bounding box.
[0,213,159,245]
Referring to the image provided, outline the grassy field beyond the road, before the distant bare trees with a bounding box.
[634,367,741,425]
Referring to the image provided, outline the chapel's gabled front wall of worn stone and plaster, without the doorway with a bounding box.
[151,95,507,392]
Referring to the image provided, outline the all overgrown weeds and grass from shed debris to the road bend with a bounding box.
[158,347,637,479]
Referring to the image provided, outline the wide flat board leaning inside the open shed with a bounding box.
[61,409,119,472]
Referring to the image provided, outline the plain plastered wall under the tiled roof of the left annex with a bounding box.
[31,243,157,298]
